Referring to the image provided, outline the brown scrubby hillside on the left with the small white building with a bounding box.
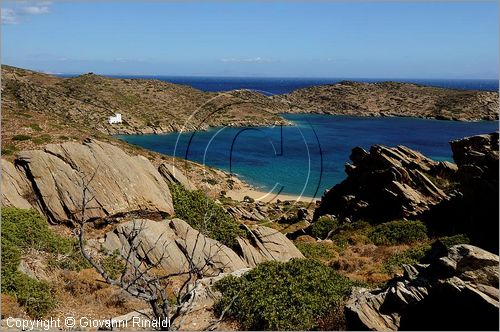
[2,66,286,134]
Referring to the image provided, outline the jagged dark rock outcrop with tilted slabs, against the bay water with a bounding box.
[315,145,456,222]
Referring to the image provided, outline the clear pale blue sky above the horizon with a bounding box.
[2,1,499,78]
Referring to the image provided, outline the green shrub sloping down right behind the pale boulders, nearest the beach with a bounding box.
[170,184,246,248]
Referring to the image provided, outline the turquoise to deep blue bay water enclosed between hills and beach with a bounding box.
[118,114,498,197]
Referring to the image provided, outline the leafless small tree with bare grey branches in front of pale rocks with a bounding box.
[73,169,228,330]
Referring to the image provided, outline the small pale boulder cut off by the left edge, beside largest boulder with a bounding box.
[1,159,34,209]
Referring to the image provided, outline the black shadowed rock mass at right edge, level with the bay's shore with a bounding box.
[450,133,499,253]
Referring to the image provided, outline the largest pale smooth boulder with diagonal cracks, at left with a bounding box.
[15,139,174,223]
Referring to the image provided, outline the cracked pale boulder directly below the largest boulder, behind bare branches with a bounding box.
[103,219,247,276]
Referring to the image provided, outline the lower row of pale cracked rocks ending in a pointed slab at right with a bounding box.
[103,219,304,275]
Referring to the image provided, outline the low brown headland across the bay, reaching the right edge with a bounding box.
[274,81,498,121]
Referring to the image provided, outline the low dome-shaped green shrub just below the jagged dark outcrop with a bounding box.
[369,220,427,245]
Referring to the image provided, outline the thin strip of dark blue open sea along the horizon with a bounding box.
[103,76,498,95]
